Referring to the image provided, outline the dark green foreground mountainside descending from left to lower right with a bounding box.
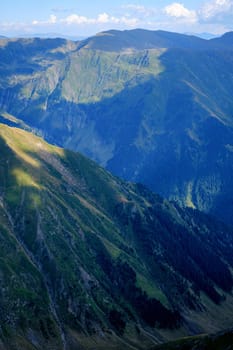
[0,123,233,350]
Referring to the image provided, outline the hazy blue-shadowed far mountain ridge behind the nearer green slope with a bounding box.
[0,30,233,223]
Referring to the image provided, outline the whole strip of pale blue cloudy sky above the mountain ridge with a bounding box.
[0,0,233,37]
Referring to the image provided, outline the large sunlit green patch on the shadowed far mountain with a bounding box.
[62,49,163,103]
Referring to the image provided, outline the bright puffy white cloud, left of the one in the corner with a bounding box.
[164,2,197,22]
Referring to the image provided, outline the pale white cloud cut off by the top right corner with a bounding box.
[199,0,233,20]
